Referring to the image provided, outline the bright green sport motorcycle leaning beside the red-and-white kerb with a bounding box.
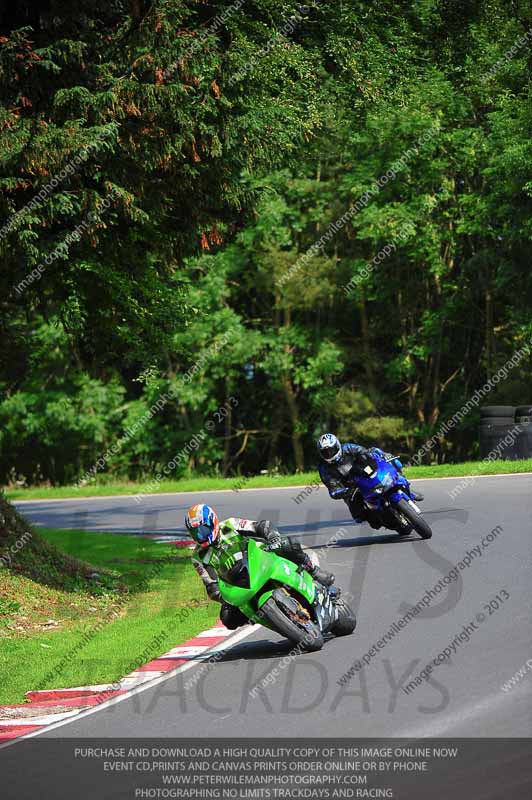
[218,539,356,650]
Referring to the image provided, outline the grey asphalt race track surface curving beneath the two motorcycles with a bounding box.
[12,475,532,739]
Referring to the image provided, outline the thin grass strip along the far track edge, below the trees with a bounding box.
[5,459,532,500]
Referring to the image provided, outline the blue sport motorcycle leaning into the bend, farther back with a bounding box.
[346,453,432,539]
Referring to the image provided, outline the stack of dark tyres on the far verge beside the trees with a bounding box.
[480,403,532,461]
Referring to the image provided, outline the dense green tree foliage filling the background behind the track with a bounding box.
[0,0,532,482]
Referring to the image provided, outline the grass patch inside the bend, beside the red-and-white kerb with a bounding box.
[0,529,219,703]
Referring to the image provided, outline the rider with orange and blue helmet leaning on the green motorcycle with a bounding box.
[185,503,334,630]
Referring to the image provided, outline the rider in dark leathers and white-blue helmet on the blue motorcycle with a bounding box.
[318,433,423,528]
